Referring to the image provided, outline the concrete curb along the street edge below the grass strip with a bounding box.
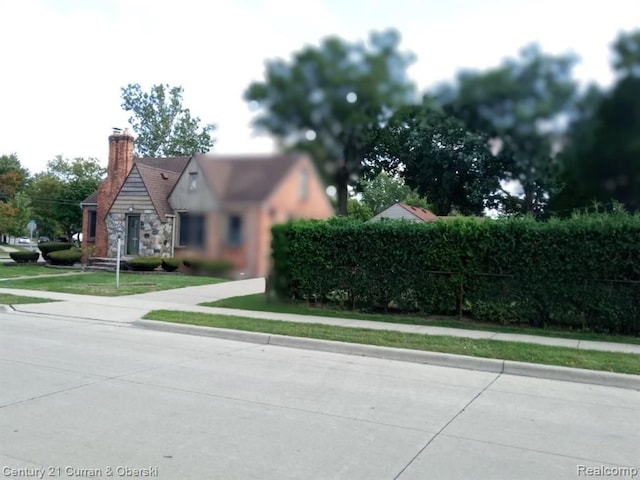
[132,320,640,391]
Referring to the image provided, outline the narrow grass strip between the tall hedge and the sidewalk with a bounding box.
[200,293,640,345]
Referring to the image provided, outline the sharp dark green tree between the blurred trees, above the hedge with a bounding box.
[372,106,503,216]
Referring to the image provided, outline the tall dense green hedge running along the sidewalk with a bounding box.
[272,213,640,334]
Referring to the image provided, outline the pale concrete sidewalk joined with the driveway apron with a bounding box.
[0,279,640,354]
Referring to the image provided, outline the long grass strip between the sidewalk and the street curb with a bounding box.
[144,310,640,375]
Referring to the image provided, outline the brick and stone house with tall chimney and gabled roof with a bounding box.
[82,130,333,276]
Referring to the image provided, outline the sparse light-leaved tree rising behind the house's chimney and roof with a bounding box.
[122,83,215,157]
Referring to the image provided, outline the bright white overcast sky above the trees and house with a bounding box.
[0,0,640,173]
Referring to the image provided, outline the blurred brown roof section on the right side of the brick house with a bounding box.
[194,154,301,202]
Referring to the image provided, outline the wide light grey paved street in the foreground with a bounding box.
[0,313,640,480]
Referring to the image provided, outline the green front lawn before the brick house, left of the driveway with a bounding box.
[0,267,226,296]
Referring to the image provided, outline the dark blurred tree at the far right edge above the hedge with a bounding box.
[552,30,640,215]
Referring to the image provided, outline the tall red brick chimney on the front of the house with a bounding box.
[94,129,134,257]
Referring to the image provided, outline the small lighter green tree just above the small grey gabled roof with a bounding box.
[358,171,432,215]
